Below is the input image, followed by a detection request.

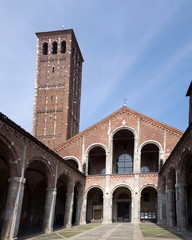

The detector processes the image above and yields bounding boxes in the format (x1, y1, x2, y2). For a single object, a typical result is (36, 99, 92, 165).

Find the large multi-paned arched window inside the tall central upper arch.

(117, 153, 133, 174)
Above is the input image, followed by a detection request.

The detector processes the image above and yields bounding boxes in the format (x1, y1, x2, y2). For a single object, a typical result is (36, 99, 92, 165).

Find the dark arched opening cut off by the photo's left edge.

(0, 142, 10, 234)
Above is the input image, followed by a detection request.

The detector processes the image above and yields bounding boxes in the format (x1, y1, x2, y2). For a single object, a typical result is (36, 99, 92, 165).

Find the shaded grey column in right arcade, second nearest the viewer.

(166, 189, 175, 227)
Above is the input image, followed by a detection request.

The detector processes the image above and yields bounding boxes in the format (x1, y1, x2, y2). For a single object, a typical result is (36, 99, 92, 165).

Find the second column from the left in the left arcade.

(43, 187, 57, 233)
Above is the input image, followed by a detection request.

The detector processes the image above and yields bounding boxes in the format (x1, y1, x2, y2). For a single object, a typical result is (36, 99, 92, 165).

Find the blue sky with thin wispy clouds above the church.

(0, 0, 192, 132)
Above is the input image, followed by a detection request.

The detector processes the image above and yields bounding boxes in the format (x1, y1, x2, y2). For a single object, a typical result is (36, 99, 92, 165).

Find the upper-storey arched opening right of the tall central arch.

(141, 144, 159, 173)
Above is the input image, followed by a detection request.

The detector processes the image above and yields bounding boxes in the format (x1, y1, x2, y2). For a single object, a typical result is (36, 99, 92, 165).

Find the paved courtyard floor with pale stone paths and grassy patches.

(19, 223, 192, 240)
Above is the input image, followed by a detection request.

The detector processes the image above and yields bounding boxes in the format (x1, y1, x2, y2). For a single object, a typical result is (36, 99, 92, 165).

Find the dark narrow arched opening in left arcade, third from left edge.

(54, 175, 68, 228)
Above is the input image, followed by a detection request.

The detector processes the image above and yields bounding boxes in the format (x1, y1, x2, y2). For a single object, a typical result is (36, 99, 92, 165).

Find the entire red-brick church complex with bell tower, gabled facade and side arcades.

(0, 30, 192, 239)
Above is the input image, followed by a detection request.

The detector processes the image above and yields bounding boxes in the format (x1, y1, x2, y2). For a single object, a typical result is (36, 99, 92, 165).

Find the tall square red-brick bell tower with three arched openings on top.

(32, 29, 83, 149)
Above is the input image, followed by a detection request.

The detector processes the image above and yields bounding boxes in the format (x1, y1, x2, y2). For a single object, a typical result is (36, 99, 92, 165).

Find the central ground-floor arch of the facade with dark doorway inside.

(112, 187, 131, 222)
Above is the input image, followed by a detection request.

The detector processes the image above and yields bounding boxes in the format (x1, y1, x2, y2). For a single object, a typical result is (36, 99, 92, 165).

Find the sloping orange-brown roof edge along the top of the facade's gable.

(53, 105, 183, 152)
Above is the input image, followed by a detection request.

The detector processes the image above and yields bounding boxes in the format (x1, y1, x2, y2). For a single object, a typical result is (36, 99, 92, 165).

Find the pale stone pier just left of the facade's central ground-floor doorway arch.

(103, 193, 112, 223)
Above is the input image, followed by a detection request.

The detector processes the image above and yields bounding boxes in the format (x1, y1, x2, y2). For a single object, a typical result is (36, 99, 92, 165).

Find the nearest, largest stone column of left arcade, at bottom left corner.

(1, 177, 26, 240)
